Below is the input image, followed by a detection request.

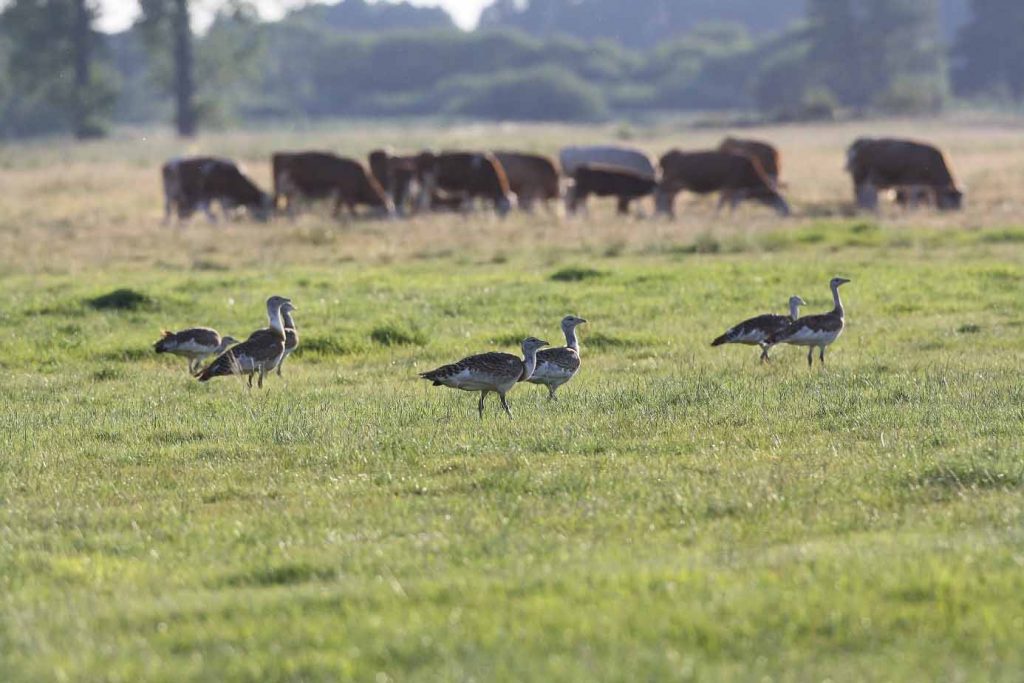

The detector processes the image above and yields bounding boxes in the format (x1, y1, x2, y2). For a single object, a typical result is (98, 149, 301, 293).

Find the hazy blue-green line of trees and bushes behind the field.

(0, 0, 1024, 137)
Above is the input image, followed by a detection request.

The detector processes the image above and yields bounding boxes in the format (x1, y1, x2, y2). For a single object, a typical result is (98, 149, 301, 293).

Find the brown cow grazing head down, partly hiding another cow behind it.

(655, 150, 790, 216)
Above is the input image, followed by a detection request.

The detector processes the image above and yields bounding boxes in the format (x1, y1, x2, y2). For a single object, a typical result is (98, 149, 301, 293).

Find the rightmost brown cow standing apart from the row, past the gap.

(846, 137, 964, 211)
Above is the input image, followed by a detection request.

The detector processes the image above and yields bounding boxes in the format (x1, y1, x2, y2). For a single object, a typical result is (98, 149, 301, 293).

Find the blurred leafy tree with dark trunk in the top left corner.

(0, 0, 116, 138)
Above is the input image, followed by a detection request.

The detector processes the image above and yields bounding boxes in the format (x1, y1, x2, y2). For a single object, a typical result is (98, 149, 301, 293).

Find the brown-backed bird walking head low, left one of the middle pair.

(420, 337, 548, 420)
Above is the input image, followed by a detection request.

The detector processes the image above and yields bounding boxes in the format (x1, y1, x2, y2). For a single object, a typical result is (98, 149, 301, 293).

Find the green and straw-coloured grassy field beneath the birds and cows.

(0, 122, 1024, 681)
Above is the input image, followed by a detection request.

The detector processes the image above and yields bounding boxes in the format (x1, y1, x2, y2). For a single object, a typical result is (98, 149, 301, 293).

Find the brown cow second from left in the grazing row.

(270, 152, 394, 216)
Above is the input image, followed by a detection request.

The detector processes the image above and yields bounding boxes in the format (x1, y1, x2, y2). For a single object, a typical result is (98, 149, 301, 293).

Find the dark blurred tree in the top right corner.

(952, 0, 1024, 100)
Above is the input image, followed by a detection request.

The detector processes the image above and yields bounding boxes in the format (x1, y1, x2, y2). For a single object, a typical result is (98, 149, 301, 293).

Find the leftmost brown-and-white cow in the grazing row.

(160, 157, 271, 223)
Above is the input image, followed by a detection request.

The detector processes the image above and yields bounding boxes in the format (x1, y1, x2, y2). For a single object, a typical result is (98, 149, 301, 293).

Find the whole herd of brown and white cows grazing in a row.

(162, 137, 963, 221)
